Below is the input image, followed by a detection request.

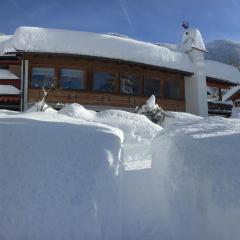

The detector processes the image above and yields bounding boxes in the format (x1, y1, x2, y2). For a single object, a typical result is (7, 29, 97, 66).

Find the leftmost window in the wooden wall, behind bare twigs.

(31, 67, 55, 88)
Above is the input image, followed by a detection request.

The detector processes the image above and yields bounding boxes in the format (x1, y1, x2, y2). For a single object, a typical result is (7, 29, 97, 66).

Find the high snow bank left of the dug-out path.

(0, 111, 122, 240)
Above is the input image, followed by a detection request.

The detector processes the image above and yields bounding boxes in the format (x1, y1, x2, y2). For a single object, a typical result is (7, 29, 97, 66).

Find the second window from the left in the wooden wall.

(60, 68, 85, 90)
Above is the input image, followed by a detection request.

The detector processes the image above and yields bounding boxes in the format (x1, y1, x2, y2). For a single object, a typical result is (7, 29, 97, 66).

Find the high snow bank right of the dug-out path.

(151, 113, 240, 240)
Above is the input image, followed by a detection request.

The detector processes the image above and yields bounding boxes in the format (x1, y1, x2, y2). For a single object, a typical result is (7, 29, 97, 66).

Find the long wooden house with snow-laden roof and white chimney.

(0, 27, 240, 116)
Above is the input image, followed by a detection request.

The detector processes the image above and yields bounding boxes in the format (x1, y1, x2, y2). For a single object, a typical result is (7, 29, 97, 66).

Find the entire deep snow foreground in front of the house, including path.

(0, 104, 240, 240)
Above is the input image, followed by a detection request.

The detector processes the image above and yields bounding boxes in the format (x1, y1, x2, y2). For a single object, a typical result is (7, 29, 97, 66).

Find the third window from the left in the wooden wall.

(93, 72, 115, 92)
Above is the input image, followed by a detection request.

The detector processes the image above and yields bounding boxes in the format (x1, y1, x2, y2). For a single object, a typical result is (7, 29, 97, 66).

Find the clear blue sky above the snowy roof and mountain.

(0, 0, 240, 43)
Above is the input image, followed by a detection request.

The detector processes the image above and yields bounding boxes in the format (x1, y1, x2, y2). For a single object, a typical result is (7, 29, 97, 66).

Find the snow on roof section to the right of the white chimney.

(205, 60, 240, 84)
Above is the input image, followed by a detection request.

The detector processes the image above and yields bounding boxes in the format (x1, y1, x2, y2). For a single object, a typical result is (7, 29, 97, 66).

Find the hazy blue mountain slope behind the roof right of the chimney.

(206, 40, 240, 69)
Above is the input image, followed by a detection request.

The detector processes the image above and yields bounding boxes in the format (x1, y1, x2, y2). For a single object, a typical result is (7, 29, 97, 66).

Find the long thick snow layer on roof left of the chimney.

(0, 27, 193, 72)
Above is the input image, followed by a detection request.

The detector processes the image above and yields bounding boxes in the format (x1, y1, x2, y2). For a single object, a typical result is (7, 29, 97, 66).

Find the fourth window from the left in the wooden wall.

(120, 74, 139, 95)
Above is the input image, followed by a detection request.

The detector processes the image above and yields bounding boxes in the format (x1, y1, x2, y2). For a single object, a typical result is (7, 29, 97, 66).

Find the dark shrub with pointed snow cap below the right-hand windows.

(135, 95, 167, 125)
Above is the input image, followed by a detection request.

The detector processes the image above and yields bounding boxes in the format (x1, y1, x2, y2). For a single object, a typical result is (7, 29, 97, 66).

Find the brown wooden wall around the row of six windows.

(25, 54, 185, 111)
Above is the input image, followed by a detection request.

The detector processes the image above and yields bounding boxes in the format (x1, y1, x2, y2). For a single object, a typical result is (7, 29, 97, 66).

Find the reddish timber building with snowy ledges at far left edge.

(0, 69, 21, 110)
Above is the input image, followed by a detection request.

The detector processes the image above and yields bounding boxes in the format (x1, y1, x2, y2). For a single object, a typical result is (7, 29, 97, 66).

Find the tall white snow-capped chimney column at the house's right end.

(183, 29, 208, 117)
